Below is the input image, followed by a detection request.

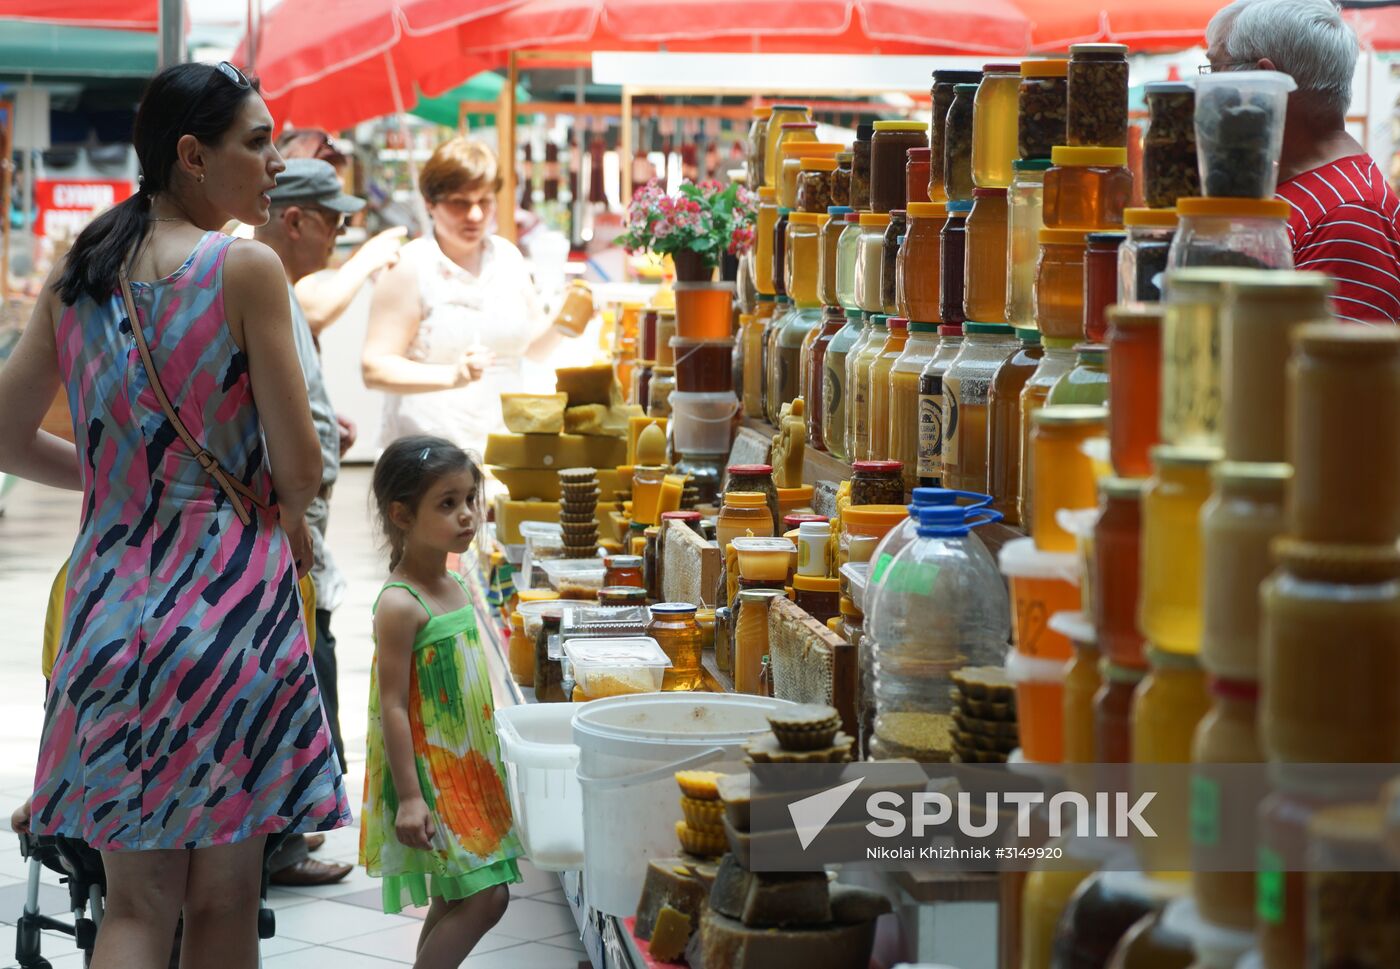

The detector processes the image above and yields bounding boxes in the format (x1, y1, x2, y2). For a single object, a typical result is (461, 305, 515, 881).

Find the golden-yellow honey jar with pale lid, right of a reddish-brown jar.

(1138, 444, 1219, 655)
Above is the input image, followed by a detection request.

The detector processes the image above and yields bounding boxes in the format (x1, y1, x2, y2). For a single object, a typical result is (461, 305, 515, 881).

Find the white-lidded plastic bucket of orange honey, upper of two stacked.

(1000, 538, 1079, 663)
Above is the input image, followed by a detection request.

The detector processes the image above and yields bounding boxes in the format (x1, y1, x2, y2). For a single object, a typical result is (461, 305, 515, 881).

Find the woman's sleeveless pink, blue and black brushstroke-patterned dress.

(32, 232, 350, 850)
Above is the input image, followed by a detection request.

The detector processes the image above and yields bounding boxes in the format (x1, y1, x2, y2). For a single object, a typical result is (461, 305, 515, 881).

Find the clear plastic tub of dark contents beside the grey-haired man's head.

(1196, 70, 1298, 199)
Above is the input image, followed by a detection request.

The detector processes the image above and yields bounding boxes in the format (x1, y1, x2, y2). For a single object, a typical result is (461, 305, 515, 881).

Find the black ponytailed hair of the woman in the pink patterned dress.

(57, 64, 258, 305)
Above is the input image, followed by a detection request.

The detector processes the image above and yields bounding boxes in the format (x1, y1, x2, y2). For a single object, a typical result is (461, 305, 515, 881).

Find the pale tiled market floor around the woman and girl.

(0, 466, 585, 969)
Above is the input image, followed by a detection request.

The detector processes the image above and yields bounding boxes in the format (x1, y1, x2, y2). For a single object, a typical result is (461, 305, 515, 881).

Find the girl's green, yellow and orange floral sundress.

(360, 573, 524, 913)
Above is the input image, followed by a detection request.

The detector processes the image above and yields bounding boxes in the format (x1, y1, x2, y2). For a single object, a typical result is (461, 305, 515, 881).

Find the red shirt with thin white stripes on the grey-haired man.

(1278, 154, 1400, 323)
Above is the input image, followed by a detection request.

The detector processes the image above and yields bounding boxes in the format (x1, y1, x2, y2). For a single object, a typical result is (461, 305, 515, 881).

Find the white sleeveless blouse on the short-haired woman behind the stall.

(379, 232, 549, 456)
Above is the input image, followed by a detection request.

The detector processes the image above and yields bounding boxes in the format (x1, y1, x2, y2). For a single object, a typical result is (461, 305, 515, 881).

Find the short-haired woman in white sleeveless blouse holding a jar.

(361, 137, 576, 455)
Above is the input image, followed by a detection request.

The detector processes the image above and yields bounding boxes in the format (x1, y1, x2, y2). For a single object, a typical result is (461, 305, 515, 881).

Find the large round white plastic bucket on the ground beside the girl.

(574, 693, 794, 917)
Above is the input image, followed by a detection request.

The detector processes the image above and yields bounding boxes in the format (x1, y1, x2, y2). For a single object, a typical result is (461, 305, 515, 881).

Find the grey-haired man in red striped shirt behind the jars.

(1205, 0, 1400, 323)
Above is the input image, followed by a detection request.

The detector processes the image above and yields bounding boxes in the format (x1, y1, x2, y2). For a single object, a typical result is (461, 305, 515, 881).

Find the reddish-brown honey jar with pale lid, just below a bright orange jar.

(1093, 477, 1147, 669)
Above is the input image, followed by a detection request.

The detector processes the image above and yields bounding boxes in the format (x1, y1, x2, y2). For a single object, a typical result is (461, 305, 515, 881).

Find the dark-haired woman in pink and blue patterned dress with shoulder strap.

(0, 63, 350, 969)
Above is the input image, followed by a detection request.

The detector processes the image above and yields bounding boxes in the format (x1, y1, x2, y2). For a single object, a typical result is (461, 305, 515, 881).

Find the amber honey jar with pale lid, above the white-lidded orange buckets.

(1030, 405, 1109, 552)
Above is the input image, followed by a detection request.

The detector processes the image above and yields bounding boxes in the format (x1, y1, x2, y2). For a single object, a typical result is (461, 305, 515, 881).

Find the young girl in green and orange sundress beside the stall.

(360, 437, 522, 969)
